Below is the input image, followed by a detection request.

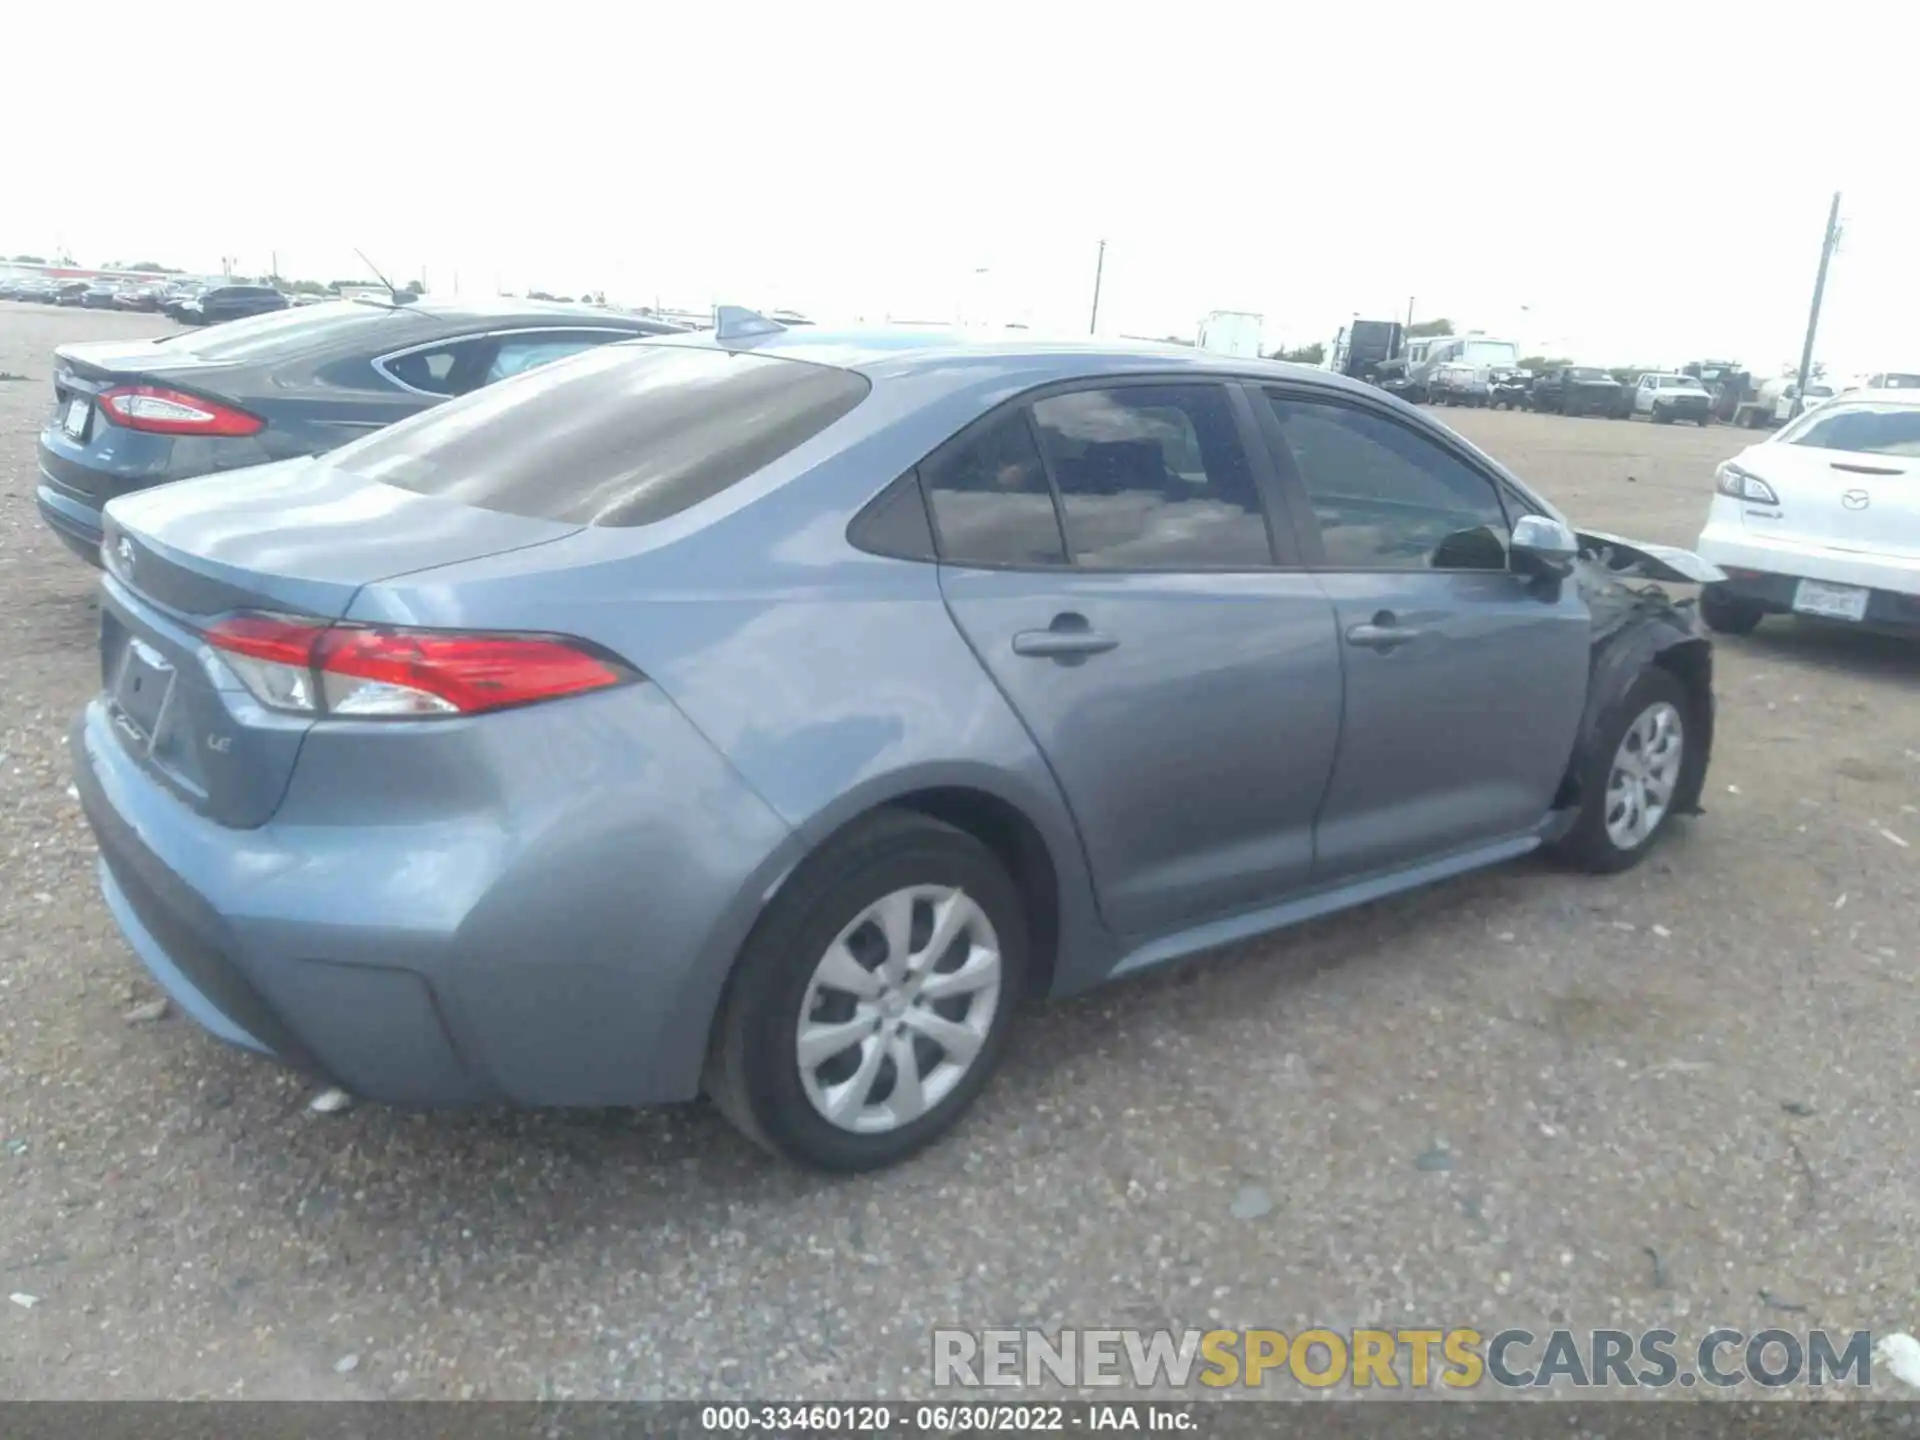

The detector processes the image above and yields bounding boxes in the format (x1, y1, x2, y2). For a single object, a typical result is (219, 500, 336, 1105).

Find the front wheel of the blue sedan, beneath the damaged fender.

(1549, 664, 1692, 876)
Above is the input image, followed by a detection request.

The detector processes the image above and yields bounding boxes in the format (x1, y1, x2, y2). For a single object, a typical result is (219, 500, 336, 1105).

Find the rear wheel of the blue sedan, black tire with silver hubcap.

(707, 810, 1027, 1173)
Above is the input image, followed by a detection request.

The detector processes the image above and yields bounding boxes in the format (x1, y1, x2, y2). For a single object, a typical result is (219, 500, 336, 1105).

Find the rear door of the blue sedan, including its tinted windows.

(922, 380, 1340, 935)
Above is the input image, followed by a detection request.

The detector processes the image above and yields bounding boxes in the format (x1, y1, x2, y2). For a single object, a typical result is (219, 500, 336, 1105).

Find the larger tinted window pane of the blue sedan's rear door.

(1033, 386, 1273, 570)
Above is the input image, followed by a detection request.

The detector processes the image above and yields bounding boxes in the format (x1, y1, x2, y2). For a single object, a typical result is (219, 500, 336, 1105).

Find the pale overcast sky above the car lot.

(0, 0, 1920, 372)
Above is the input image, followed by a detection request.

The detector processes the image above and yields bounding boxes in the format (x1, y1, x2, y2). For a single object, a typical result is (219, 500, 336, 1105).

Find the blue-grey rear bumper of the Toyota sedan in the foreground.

(71, 685, 797, 1106)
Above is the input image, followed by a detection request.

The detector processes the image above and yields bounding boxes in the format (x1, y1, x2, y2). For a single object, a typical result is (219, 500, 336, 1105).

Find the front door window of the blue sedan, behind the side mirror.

(1271, 396, 1509, 570)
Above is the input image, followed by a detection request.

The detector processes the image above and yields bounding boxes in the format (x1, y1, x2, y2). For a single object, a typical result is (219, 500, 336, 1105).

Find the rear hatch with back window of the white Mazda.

(1751, 399, 1920, 559)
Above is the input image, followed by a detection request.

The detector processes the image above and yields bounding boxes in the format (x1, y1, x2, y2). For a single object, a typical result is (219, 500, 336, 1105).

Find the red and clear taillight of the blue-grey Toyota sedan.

(207, 614, 639, 720)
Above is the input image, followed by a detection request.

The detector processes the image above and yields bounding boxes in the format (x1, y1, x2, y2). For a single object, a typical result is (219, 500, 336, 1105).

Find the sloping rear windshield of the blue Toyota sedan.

(334, 342, 868, 526)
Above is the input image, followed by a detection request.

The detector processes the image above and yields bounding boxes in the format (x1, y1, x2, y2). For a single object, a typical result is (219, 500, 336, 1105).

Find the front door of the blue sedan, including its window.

(1263, 388, 1592, 881)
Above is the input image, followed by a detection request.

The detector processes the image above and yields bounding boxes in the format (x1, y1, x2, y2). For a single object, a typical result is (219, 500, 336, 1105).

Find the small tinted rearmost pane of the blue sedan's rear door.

(922, 409, 1068, 564)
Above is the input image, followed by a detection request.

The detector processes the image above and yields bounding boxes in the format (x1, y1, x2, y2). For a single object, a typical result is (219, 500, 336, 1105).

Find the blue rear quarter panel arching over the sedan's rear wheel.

(349, 401, 1114, 1025)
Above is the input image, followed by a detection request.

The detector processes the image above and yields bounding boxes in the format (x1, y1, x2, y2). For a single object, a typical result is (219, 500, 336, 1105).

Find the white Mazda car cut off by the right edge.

(1695, 390, 1920, 636)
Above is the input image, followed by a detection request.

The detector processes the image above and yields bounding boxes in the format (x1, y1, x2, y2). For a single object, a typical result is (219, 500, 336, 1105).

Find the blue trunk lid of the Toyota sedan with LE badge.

(100, 459, 580, 829)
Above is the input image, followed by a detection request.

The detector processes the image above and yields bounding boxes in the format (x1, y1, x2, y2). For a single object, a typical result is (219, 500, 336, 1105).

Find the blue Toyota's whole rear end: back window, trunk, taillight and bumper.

(73, 346, 866, 1104)
